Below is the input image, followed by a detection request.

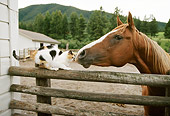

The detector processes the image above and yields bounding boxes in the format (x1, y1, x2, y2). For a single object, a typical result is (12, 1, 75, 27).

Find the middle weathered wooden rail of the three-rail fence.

(10, 84, 170, 106)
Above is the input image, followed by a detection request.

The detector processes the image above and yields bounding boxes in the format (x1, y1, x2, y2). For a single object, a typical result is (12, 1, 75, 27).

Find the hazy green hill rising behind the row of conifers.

(19, 4, 93, 22)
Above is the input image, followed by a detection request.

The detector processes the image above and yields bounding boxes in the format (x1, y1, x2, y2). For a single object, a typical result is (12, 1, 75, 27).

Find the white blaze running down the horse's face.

(76, 30, 118, 59)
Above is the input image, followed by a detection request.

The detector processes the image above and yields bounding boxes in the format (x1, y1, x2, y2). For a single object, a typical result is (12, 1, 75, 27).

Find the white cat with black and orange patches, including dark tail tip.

(13, 46, 75, 71)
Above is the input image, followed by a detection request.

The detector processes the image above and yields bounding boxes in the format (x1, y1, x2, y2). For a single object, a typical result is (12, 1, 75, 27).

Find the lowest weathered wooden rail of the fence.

(10, 100, 135, 116)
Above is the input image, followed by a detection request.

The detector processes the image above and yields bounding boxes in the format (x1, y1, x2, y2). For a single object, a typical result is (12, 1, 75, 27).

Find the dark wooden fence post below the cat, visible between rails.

(36, 78, 52, 116)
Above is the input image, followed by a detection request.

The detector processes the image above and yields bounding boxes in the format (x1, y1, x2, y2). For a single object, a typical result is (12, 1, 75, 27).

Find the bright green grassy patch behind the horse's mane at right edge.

(150, 32, 170, 52)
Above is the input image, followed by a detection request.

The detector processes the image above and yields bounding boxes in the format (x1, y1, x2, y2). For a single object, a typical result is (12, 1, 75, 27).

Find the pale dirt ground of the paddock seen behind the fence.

(20, 61, 144, 116)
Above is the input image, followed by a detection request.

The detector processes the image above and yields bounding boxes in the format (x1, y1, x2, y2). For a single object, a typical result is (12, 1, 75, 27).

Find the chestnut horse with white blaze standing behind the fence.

(76, 12, 170, 116)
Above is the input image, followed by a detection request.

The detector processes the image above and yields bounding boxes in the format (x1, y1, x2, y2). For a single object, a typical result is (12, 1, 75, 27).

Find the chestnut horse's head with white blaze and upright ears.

(76, 12, 136, 68)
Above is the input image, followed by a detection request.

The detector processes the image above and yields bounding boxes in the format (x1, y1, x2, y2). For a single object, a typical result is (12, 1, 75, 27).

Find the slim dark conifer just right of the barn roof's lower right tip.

(62, 14, 69, 39)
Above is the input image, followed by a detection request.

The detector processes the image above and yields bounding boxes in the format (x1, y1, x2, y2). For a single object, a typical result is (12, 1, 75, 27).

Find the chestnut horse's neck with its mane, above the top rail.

(133, 33, 170, 74)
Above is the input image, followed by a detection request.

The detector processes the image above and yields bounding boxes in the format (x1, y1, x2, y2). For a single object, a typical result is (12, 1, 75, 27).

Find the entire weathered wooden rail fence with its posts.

(9, 66, 170, 116)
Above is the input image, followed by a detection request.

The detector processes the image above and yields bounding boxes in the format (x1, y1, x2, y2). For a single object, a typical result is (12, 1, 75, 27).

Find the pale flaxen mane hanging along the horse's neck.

(136, 30, 170, 74)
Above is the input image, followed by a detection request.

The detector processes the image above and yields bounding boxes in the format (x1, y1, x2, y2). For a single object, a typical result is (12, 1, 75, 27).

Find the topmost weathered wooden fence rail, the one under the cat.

(9, 66, 170, 87)
